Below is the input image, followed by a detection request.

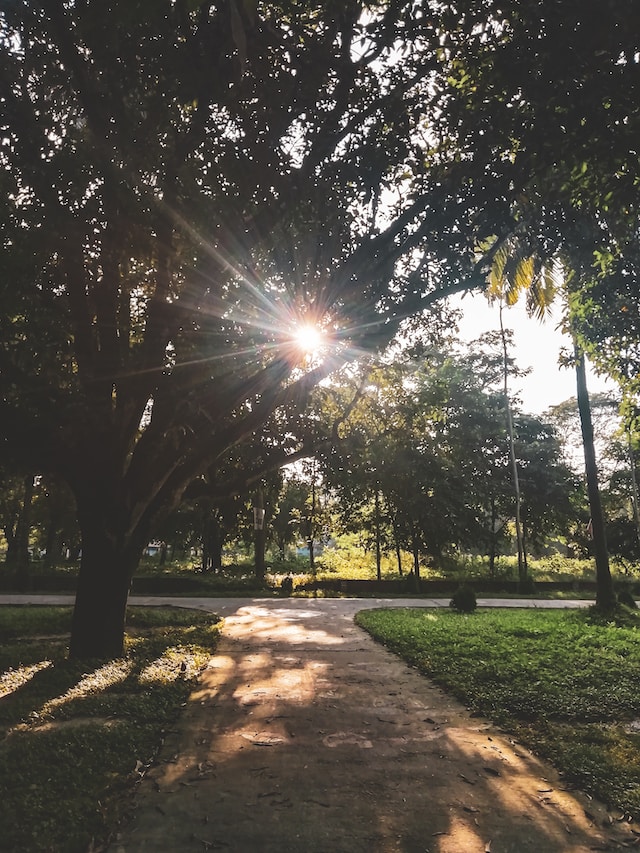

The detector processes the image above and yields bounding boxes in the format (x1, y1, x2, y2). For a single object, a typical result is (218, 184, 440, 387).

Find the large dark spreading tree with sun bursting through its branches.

(0, 0, 496, 656)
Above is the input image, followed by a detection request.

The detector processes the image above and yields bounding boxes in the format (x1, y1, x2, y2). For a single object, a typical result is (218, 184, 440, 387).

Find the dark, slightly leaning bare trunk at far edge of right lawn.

(574, 344, 616, 610)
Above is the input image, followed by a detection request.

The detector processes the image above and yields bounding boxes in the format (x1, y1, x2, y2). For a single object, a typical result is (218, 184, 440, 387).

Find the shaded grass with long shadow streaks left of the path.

(0, 607, 218, 853)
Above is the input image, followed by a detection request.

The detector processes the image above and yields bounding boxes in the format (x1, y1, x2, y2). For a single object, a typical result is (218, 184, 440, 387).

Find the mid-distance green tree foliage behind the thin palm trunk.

(318, 343, 586, 575)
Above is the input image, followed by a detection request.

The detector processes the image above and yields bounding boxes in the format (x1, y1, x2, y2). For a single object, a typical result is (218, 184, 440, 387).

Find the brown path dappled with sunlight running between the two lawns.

(109, 601, 637, 853)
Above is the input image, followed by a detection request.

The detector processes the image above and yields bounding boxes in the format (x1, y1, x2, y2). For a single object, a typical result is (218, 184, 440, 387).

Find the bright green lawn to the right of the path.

(356, 609, 640, 819)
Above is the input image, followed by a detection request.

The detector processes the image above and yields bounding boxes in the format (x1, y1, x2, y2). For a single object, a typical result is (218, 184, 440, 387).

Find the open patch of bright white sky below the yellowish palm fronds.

(455, 293, 612, 414)
